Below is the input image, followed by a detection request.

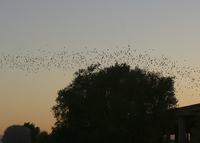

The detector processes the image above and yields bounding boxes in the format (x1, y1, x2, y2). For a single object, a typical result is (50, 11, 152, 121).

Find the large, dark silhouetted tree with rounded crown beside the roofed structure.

(52, 63, 177, 143)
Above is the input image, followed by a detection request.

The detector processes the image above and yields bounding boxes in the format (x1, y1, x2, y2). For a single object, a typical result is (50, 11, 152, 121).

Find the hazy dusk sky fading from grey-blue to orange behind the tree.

(0, 0, 200, 135)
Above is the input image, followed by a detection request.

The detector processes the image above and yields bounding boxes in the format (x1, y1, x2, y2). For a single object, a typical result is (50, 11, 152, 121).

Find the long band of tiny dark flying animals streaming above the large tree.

(0, 45, 200, 95)
